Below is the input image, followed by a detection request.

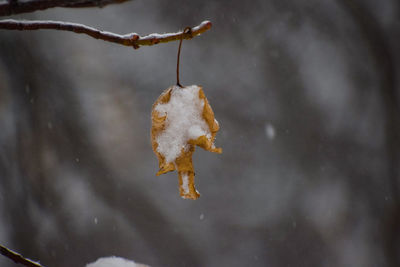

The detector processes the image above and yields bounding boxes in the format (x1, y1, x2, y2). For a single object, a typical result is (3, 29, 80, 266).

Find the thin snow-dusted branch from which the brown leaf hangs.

(0, 19, 212, 49)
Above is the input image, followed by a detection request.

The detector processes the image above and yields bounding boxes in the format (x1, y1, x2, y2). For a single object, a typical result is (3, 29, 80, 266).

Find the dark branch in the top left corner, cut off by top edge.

(0, 0, 128, 16)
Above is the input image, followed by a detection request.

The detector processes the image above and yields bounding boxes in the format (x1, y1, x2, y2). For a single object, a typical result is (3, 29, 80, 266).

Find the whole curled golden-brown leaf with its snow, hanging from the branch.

(151, 85, 222, 199)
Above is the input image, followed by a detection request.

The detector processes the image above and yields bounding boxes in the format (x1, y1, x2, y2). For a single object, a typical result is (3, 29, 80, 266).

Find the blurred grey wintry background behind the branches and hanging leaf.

(0, 0, 400, 267)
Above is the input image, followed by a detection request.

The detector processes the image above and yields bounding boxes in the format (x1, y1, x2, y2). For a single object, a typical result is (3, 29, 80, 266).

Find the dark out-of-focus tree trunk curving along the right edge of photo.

(338, 0, 400, 267)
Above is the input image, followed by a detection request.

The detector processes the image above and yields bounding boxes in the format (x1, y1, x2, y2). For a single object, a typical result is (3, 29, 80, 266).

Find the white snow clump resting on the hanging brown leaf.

(155, 85, 211, 163)
